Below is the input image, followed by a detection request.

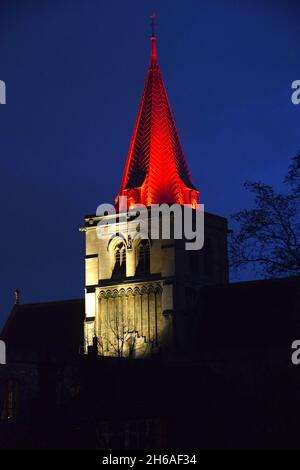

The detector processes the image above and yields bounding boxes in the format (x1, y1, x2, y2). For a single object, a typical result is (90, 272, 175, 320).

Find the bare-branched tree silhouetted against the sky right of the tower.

(230, 152, 300, 277)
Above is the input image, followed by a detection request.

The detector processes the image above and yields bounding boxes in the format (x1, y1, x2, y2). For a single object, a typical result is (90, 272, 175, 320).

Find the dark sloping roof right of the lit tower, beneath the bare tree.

(198, 276, 300, 351)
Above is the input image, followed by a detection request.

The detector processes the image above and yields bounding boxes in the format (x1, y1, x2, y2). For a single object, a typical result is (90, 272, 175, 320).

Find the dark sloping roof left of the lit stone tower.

(0, 299, 84, 361)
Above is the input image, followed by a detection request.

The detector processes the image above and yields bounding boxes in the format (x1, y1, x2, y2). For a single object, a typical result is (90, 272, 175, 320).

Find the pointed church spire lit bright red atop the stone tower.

(116, 17, 199, 207)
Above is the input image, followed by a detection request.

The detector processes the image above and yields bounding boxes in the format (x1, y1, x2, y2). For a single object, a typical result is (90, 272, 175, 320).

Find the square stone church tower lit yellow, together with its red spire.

(82, 28, 228, 358)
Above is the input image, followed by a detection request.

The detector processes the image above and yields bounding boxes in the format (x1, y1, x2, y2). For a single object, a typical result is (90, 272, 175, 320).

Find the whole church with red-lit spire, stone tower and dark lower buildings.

(0, 26, 300, 450)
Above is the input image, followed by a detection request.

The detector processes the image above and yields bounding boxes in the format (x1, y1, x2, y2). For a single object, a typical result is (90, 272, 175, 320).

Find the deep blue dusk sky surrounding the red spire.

(0, 0, 300, 323)
